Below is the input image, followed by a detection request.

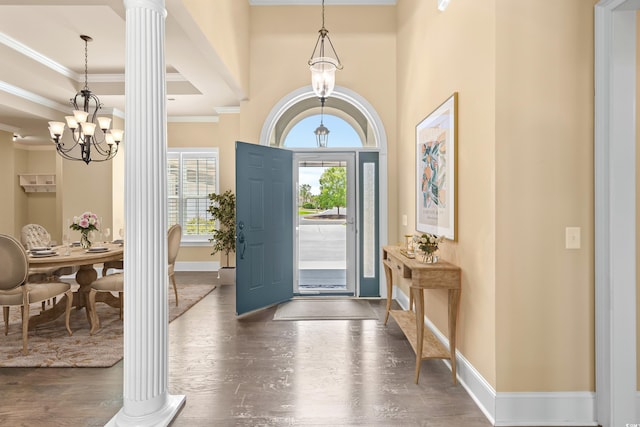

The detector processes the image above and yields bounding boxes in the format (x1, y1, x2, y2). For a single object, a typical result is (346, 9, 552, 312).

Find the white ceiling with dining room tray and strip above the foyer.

(0, 0, 395, 145)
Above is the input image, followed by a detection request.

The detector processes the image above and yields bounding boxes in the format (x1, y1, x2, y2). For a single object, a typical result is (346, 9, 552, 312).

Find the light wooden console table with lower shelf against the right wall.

(382, 246, 461, 384)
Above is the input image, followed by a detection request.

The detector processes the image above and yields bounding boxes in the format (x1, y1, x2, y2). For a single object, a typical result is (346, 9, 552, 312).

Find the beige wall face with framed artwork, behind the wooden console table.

(398, 0, 496, 386)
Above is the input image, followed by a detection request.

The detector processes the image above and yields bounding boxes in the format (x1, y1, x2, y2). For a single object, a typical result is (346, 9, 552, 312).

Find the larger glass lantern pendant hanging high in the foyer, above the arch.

(309, 0, 342, 99)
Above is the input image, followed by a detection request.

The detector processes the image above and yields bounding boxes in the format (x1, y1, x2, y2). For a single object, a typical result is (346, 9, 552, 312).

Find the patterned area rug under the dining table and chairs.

(0, 283, 216, 368)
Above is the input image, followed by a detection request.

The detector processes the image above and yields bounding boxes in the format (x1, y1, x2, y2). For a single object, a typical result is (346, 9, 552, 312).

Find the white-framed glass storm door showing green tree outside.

(293, 153, 357, 295)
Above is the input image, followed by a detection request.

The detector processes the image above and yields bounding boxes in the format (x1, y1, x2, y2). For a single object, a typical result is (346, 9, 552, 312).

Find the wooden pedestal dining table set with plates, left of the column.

(28, 242, 124, 330)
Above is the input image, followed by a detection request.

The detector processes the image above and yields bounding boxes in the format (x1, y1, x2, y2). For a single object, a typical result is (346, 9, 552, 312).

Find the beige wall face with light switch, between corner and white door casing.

(495, 0, 596, 391)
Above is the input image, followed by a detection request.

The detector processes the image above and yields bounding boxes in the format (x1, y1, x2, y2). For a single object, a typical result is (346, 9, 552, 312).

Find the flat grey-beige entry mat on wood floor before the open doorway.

(273, 299, 378, 320)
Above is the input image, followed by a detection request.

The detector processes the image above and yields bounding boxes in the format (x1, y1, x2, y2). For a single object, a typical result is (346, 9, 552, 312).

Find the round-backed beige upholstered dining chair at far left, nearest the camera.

(0, 234, 73, 355)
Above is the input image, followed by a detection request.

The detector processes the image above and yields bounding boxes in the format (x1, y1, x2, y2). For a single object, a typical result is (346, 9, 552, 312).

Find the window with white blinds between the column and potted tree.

(167, 149, 218, 243)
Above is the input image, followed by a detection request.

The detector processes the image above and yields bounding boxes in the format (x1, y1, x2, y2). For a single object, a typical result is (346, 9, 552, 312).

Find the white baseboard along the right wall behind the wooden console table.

(395, 287, 596, 427)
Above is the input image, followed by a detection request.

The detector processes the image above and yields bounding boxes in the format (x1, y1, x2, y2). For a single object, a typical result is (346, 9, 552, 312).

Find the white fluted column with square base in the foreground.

(107, 0, 185, 426)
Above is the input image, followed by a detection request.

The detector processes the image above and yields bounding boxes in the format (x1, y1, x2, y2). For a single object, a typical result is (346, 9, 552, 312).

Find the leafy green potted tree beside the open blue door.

(208, 190, 236, 285)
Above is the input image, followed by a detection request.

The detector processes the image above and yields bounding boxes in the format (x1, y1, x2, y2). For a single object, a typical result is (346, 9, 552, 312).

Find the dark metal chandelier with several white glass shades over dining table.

(49, 35, 124, 164)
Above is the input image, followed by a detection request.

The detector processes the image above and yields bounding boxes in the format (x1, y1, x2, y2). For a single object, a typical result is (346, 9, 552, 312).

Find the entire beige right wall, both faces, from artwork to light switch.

(397, 0, 595, 392)
